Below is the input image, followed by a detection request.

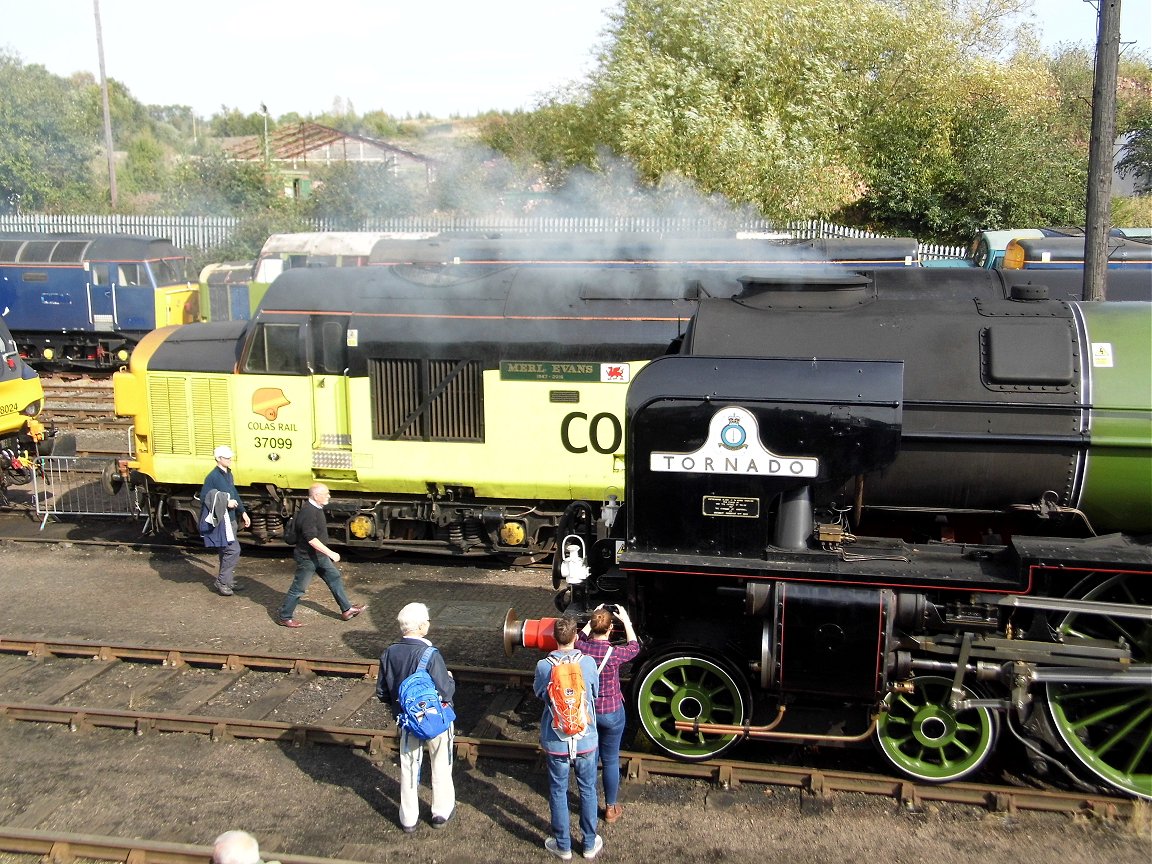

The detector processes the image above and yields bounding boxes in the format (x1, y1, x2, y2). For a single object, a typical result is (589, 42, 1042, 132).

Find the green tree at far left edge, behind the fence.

(0, 50, 100, 211)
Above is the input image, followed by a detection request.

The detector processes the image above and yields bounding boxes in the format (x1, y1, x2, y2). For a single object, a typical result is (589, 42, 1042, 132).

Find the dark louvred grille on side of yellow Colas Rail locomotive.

(369, 359, 484, 442)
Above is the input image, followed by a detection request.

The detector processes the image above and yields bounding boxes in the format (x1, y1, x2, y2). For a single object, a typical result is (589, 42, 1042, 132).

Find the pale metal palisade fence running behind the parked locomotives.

(0, 213, 964, 258)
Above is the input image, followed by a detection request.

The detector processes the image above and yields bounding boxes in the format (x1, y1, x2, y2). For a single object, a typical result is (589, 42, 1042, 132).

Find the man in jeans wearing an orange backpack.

(532, 616, 604, 861)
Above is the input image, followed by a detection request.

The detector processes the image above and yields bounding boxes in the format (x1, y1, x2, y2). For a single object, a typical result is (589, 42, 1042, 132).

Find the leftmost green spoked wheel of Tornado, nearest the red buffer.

(636, 655, 750, 760)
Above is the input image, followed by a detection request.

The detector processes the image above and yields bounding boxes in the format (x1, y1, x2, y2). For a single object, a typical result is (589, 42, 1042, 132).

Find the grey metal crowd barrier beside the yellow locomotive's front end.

(32, 456, 144, 531)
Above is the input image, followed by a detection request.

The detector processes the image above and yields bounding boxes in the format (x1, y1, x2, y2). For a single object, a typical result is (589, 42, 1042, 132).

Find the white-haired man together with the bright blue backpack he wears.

(376, 602, 456, 834)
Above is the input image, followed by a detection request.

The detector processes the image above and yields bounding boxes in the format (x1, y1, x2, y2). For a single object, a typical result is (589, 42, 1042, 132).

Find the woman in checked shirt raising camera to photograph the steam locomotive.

(576, 604, 641, 824)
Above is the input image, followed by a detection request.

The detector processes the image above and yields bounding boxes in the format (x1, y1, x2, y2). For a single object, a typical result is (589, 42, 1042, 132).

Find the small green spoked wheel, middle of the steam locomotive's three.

(876, 676, 1000, 783)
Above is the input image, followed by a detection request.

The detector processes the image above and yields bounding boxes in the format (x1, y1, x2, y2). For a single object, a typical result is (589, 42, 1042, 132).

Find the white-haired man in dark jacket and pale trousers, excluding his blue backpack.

(376, 602, 456, 834)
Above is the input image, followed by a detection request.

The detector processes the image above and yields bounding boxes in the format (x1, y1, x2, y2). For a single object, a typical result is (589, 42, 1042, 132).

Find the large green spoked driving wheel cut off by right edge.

(1047, 574, 1152, 798)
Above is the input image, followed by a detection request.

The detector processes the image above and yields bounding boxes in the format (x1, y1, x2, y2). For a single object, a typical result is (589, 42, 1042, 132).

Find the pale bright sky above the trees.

(0, 0, 1152, 119)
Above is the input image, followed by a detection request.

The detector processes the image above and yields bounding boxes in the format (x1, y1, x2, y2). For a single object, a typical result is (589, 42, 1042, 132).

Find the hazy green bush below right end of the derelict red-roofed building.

(309, 162, 416, 230)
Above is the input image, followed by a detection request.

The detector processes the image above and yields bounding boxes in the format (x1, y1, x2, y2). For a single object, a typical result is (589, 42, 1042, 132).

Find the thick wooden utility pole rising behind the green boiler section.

(1084, 0, 1121, 300)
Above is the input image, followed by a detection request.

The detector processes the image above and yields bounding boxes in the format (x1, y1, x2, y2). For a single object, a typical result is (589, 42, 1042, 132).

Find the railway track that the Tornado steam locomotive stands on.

(0, 637, 1137, 819)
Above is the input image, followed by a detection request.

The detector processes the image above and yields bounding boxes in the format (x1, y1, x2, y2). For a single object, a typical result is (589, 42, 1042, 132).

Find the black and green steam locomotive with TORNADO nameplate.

(520, 271, 1152, 797)
